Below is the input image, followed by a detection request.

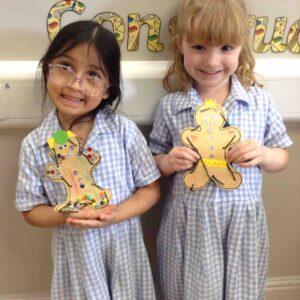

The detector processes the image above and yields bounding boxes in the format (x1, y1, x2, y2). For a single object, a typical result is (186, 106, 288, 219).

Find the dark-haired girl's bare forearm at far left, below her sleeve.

(23, 204, 67, 227)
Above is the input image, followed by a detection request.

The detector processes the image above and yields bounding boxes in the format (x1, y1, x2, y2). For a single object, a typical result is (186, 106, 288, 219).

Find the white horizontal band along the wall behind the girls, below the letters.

(0, 58, 300, 128)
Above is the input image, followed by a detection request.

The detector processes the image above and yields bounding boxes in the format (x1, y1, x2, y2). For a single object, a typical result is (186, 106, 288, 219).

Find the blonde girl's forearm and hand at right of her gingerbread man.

(227, 140, 289, 173)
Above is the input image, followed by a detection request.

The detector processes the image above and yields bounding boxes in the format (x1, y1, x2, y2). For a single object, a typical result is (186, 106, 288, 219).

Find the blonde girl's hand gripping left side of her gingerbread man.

(165, 146, 200, 173)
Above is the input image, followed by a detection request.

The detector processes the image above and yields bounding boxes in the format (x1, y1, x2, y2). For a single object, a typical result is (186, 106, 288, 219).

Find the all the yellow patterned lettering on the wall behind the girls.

(48, 0, 300, 54)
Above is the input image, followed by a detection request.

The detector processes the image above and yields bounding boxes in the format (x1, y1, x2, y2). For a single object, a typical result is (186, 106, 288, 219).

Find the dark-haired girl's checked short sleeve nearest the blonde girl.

(127, 124, 160, 187)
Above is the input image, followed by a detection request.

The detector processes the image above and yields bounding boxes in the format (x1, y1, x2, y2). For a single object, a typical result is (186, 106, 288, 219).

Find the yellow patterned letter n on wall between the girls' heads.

(127, 14, 164, 52)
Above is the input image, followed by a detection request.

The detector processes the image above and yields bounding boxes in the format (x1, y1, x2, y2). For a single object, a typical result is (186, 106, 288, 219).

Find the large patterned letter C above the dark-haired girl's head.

(48, 0, 85, 41)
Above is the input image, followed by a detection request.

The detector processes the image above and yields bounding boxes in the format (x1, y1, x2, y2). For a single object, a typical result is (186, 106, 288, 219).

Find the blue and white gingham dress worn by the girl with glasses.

(15, 111, 160, 300)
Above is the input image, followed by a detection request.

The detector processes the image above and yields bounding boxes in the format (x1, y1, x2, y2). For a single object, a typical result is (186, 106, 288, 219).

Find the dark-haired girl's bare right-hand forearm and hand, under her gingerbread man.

(66, 180, 160, 228)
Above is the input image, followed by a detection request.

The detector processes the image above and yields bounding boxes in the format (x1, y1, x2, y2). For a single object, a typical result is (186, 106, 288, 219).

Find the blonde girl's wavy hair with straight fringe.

(163, 0, 258, 92)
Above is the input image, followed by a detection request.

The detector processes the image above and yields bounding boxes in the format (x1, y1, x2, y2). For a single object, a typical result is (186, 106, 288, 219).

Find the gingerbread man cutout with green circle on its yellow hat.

(46, 130, 111, 212)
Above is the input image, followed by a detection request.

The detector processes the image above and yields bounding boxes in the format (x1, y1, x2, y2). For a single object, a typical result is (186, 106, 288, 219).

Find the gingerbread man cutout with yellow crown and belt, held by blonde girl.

(181, 99, 242, 190)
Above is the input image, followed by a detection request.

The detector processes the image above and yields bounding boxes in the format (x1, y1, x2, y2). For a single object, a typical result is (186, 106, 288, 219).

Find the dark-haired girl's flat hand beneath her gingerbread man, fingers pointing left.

(66, 205, 118, 229)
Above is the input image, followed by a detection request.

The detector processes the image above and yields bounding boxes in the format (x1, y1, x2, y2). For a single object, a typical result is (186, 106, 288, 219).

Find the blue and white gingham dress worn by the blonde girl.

(150, 75, 292, 300)
